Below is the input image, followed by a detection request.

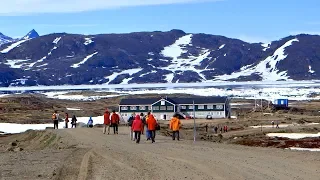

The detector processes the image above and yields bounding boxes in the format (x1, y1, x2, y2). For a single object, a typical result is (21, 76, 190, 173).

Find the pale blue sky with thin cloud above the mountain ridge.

(0, 0, 320, 42)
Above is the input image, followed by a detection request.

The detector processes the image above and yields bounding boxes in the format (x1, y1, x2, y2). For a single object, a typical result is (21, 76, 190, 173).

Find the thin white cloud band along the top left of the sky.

(0, 0, 223, 15)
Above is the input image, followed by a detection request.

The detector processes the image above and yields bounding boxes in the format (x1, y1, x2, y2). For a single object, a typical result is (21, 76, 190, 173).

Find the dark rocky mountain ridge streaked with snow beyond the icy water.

(0, 30, 320, 86)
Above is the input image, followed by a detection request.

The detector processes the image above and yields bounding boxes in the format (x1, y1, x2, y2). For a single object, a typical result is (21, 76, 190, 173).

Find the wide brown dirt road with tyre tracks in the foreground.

(0, 127, 320, 180)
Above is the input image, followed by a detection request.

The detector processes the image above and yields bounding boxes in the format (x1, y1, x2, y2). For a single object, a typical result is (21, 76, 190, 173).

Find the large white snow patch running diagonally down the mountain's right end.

(216, 38, 299, 81)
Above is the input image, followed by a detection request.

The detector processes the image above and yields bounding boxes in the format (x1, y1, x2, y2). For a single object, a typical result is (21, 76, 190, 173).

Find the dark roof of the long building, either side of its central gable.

(120, 96, 227, 105)
